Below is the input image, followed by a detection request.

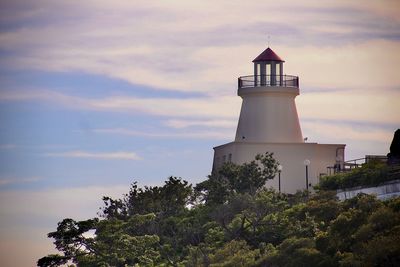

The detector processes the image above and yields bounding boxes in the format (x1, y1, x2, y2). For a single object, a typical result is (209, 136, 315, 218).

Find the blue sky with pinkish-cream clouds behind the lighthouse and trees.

(0, 0, 400, 266)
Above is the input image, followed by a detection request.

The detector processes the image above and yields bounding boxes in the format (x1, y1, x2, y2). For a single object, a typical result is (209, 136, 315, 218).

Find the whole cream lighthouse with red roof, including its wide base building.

(213, 47, 345, 193)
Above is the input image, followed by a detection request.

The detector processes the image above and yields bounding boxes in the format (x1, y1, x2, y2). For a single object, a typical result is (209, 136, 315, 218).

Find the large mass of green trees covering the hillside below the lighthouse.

(38, 153, 400, 267)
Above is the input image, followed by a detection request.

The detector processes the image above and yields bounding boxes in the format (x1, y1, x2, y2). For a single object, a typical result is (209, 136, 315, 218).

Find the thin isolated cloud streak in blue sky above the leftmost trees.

(45, 150, 141, 160)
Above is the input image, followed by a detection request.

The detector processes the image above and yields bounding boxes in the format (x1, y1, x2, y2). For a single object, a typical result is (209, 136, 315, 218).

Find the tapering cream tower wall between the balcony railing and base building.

(235, 86, 303, 143)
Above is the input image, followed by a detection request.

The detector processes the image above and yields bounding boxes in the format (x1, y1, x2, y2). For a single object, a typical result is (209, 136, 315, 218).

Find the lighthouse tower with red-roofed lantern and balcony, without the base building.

(235, 47, 303, 143)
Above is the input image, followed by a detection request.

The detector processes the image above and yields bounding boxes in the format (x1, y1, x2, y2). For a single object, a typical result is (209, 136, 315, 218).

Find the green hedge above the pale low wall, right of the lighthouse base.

(318, 161, 400, 190)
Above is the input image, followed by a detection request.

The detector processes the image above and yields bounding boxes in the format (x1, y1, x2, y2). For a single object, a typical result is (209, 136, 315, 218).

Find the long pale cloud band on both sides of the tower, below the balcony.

(0, 85, 400, 128)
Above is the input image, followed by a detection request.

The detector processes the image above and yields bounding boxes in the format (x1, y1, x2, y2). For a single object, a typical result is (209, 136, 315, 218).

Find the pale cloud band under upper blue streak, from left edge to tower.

(0, 90, 240, 118)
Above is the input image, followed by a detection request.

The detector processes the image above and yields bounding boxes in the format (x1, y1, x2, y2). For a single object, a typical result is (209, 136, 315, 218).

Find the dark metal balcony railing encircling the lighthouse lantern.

(238, 75, 299, 88)
